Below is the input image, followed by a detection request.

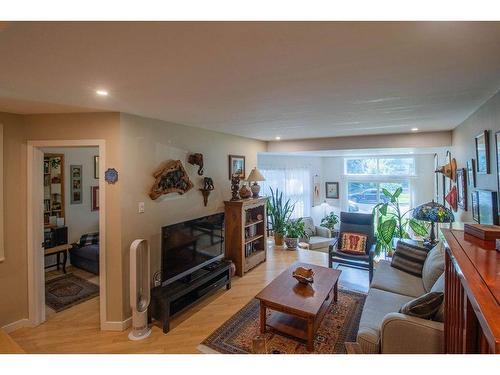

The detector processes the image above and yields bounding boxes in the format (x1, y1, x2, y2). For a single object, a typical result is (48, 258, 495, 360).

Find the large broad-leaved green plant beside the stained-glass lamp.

(373, 187, 427, 255)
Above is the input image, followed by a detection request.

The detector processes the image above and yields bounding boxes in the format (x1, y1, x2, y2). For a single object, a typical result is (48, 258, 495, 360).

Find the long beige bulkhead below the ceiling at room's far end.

(268, 131, 451, 152)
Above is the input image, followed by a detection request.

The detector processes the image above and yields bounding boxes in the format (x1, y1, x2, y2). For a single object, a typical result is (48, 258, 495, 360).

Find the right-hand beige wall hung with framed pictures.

(452, 91, 500, 222)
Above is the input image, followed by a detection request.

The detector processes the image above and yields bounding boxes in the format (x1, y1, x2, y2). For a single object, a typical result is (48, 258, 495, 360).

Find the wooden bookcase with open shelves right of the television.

(224, 197, 267, 277)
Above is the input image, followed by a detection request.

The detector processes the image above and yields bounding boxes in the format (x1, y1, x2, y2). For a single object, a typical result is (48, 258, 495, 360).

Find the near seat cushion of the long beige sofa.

(357, 290, 413, 354)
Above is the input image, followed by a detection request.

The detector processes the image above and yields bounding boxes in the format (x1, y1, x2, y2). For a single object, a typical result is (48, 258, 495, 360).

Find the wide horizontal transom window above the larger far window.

(345, 157, 415, 176)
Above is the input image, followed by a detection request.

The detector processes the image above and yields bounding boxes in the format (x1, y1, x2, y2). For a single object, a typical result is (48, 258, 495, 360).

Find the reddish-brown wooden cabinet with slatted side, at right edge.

(441, 229, 500, 354)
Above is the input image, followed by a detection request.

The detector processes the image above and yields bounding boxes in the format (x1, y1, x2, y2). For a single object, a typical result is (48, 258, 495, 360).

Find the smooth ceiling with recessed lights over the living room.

(0, 22, 500, 140)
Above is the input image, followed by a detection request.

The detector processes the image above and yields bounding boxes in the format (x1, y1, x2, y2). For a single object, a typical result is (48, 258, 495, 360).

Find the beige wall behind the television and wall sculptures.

(120, 114, 266, 316)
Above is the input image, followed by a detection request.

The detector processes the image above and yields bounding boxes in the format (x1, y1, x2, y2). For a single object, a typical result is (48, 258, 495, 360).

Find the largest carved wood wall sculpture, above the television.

(149, 160, 193, 200)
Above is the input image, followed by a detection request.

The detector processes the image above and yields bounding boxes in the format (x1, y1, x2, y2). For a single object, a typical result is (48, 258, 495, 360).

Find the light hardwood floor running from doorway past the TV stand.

(7, 242, 368, 353)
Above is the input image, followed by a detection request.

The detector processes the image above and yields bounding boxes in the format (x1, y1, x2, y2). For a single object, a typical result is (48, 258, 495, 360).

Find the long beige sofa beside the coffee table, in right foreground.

(357, 245, 444, 354)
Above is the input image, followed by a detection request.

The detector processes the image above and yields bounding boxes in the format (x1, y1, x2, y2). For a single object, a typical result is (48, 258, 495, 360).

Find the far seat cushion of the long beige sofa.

(370, 260, 426, 298)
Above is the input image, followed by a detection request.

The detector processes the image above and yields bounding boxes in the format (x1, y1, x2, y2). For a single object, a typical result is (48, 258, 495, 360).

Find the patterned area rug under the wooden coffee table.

(198, 289, 366, 354)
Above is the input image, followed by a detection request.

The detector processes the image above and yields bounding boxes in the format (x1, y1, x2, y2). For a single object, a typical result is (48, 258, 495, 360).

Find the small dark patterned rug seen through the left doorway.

(45, 274, 99, 312)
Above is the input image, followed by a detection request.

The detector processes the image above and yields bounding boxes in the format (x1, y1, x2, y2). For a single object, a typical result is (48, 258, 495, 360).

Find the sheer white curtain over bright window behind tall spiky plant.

(260, 168, 312, 219)
